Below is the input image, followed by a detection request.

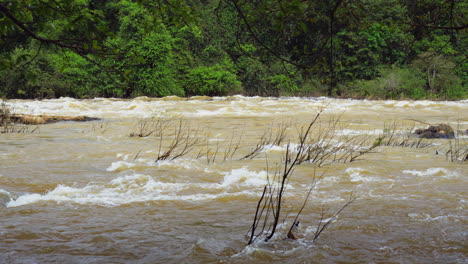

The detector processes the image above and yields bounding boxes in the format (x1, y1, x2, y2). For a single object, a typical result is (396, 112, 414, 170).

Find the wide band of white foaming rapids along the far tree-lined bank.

(8, 96, 467, 118)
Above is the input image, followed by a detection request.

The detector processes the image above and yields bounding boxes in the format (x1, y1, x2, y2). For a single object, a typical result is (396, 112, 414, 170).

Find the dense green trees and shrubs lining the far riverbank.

(0, 0, 468, 99)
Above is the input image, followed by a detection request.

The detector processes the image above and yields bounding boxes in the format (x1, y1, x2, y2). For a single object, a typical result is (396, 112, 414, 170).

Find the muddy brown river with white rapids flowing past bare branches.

(0, 96, 468, 263)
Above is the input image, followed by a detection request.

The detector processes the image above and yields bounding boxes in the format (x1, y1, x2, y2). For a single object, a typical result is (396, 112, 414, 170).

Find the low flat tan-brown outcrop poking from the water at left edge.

(0, 112, 99, 125)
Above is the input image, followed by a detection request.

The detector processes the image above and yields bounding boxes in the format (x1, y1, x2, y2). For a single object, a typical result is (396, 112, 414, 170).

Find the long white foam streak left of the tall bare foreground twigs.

(5, 171, 274, 207)
